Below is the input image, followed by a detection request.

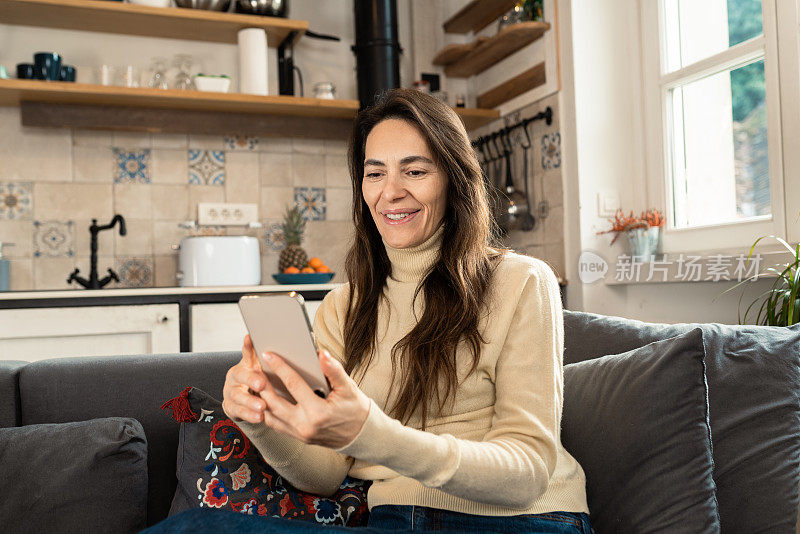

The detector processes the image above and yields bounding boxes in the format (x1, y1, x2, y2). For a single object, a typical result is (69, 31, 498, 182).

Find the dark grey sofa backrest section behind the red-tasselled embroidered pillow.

(16, 352, 241, 525)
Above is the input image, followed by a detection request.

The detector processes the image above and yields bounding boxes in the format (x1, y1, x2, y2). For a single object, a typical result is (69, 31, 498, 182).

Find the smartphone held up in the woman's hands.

(239, 291, 330, 402)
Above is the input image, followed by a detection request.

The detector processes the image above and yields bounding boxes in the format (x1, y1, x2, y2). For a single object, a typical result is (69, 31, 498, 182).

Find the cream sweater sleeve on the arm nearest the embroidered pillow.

(236, 291, 353, 496)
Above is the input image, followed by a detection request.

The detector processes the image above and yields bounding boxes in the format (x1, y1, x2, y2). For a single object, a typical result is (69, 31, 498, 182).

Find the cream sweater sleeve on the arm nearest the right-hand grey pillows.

(338, 262, 564, 509)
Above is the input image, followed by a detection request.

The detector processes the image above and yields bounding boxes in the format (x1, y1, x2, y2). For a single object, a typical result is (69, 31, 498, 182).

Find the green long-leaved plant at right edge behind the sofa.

(723, 235, 800, 326)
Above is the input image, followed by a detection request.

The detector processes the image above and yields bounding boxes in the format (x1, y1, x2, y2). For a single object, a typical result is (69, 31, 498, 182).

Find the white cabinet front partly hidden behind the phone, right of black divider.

(191, 300, 322, 352)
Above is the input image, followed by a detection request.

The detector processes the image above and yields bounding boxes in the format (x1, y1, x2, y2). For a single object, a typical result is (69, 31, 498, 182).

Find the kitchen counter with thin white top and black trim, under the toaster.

(0, 284, 341, 352)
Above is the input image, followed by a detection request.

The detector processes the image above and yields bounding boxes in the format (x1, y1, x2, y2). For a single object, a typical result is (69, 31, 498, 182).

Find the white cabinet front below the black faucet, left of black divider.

(0, 304, 180, 361)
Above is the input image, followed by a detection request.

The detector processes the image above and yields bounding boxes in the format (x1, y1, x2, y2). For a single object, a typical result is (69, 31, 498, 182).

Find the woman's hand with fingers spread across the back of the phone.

(260, 351, 369, 449)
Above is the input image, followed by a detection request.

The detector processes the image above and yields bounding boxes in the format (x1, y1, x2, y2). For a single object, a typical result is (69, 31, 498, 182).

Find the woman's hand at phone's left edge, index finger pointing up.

(222, 336, 268, 423)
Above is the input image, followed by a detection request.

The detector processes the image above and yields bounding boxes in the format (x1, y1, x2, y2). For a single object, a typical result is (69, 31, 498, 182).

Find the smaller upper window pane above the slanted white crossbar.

(664, 0, 763, 72)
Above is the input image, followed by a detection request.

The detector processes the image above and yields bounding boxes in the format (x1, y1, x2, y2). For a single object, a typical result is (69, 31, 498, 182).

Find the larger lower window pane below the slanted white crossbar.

(669, 59, 771, 228)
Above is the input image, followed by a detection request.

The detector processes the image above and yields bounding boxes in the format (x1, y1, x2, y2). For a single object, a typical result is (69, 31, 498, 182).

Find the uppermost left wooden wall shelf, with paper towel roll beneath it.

(0, 0, 308, 47)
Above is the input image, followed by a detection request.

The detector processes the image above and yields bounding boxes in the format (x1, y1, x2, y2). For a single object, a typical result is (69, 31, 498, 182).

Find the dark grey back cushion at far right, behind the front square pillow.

(564, 311, 800, 532)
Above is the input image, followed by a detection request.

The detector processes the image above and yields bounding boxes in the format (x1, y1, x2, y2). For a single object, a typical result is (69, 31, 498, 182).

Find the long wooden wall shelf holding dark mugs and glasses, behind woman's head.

(0, 80, 500, 139)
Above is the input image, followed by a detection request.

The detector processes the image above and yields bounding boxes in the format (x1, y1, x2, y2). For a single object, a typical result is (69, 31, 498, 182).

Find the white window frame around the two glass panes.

(639, 0, 800, 253)
